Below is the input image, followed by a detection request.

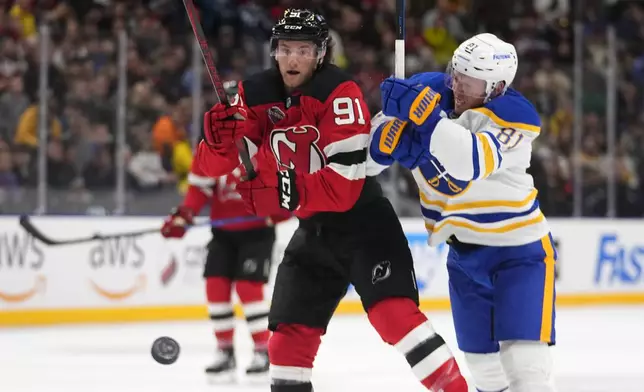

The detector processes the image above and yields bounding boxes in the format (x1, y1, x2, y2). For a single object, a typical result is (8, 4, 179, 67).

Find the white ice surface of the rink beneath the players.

(0, 307, 644, 392)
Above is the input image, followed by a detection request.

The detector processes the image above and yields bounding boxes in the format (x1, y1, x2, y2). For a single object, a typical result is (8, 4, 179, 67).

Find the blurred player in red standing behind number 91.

(161, 84, 290, 382)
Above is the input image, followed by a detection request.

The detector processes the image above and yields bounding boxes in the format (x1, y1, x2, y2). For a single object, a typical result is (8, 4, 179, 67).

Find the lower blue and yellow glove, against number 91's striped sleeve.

(369, 118, 431, 170)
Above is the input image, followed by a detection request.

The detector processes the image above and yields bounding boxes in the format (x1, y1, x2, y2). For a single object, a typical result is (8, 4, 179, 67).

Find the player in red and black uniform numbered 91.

(197, 9, 467, 392)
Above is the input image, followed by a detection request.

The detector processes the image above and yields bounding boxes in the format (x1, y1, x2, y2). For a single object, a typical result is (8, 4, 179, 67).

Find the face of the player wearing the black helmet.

(275, 41, 318, 88)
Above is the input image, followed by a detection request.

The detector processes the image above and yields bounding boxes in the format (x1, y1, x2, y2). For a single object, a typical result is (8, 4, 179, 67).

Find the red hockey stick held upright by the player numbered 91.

(183, 0, 257, 180)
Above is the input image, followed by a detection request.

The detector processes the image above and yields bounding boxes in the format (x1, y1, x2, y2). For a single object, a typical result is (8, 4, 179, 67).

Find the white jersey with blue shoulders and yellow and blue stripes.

(367, 77, 550, 246)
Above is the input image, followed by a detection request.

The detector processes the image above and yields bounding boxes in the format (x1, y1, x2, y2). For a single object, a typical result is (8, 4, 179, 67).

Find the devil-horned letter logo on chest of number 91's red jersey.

(271, 125, 324, 173)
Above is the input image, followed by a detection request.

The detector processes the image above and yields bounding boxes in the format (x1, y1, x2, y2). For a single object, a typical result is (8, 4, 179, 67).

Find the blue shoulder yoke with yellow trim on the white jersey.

(472, 89, 541, 132)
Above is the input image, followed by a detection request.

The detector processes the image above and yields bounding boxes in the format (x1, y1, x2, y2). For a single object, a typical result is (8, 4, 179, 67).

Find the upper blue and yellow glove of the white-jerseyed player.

(380, 77, 441, 131)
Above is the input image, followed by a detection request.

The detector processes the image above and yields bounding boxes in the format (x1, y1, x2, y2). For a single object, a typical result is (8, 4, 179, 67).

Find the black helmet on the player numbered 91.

(271, 8, 329, 58)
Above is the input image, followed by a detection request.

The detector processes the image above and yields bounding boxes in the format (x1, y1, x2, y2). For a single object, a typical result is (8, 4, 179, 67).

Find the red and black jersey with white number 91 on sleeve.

(197, 65, 381, 218)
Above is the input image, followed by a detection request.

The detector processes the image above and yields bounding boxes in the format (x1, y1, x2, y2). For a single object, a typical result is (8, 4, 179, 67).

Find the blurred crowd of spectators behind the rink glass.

(0, 0, 644, 217)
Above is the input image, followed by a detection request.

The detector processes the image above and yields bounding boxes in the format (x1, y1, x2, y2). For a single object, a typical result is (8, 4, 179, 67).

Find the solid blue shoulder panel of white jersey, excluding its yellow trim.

(483, 88, 541, 127)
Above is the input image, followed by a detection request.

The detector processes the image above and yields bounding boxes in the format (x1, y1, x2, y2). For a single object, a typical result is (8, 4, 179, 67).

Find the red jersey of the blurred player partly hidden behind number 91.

(183, 161, 291, 231)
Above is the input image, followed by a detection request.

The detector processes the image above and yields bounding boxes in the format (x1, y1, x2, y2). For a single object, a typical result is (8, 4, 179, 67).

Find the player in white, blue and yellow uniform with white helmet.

(368, 34, 557, 392)
